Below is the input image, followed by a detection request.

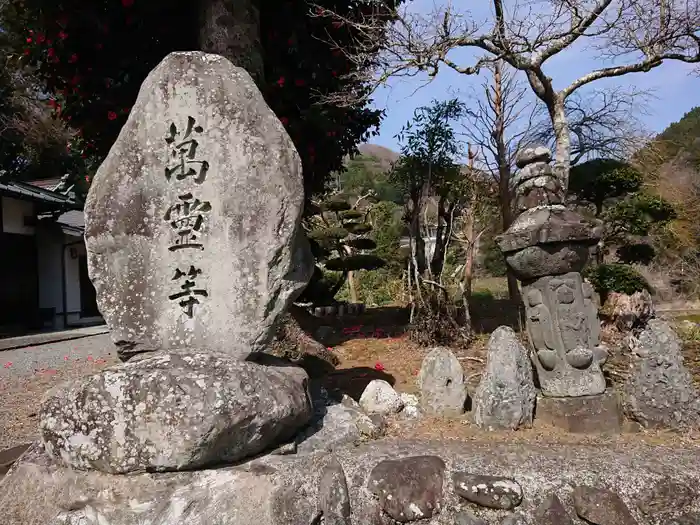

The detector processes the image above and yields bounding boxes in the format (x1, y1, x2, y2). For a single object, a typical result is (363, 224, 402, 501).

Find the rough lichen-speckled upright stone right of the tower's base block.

(623, 319, 700, 430)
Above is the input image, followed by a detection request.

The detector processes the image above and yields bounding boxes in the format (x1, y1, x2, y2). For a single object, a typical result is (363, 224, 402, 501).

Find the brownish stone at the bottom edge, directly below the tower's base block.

(573, 485, 638, 525)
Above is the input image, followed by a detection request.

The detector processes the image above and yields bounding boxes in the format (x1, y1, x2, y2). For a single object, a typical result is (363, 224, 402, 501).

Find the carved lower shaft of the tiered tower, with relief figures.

(523, 272, 608, 397)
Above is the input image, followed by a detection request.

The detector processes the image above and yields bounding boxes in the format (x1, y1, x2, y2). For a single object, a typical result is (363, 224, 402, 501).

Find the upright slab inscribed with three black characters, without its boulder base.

(85, 52, 313, 357)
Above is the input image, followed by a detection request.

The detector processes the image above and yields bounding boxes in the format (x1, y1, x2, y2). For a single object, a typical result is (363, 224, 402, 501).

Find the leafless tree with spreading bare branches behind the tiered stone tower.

(316, 0, 700, 191)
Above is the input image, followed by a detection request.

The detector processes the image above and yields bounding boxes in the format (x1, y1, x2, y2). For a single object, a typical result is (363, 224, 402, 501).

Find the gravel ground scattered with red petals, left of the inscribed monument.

(0, 334, 117, 450)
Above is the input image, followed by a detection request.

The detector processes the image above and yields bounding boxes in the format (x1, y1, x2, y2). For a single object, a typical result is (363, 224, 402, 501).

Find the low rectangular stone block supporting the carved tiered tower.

(535, 390, 623, 434)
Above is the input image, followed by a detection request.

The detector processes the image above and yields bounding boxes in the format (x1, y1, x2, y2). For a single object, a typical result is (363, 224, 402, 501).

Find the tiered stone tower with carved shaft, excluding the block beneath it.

(497, 147, 610, 430)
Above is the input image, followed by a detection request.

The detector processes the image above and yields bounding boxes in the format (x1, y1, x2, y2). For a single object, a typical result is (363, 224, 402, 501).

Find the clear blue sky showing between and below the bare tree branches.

(370, 0, 700, 150)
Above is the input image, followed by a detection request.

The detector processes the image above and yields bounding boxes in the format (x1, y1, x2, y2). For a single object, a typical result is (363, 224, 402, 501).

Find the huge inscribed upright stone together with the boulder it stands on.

(34, 52, 313, 474)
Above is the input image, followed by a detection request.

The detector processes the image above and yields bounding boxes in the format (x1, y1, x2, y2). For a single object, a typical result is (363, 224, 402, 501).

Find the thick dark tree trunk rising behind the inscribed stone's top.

(199, 0, 264, 86)
